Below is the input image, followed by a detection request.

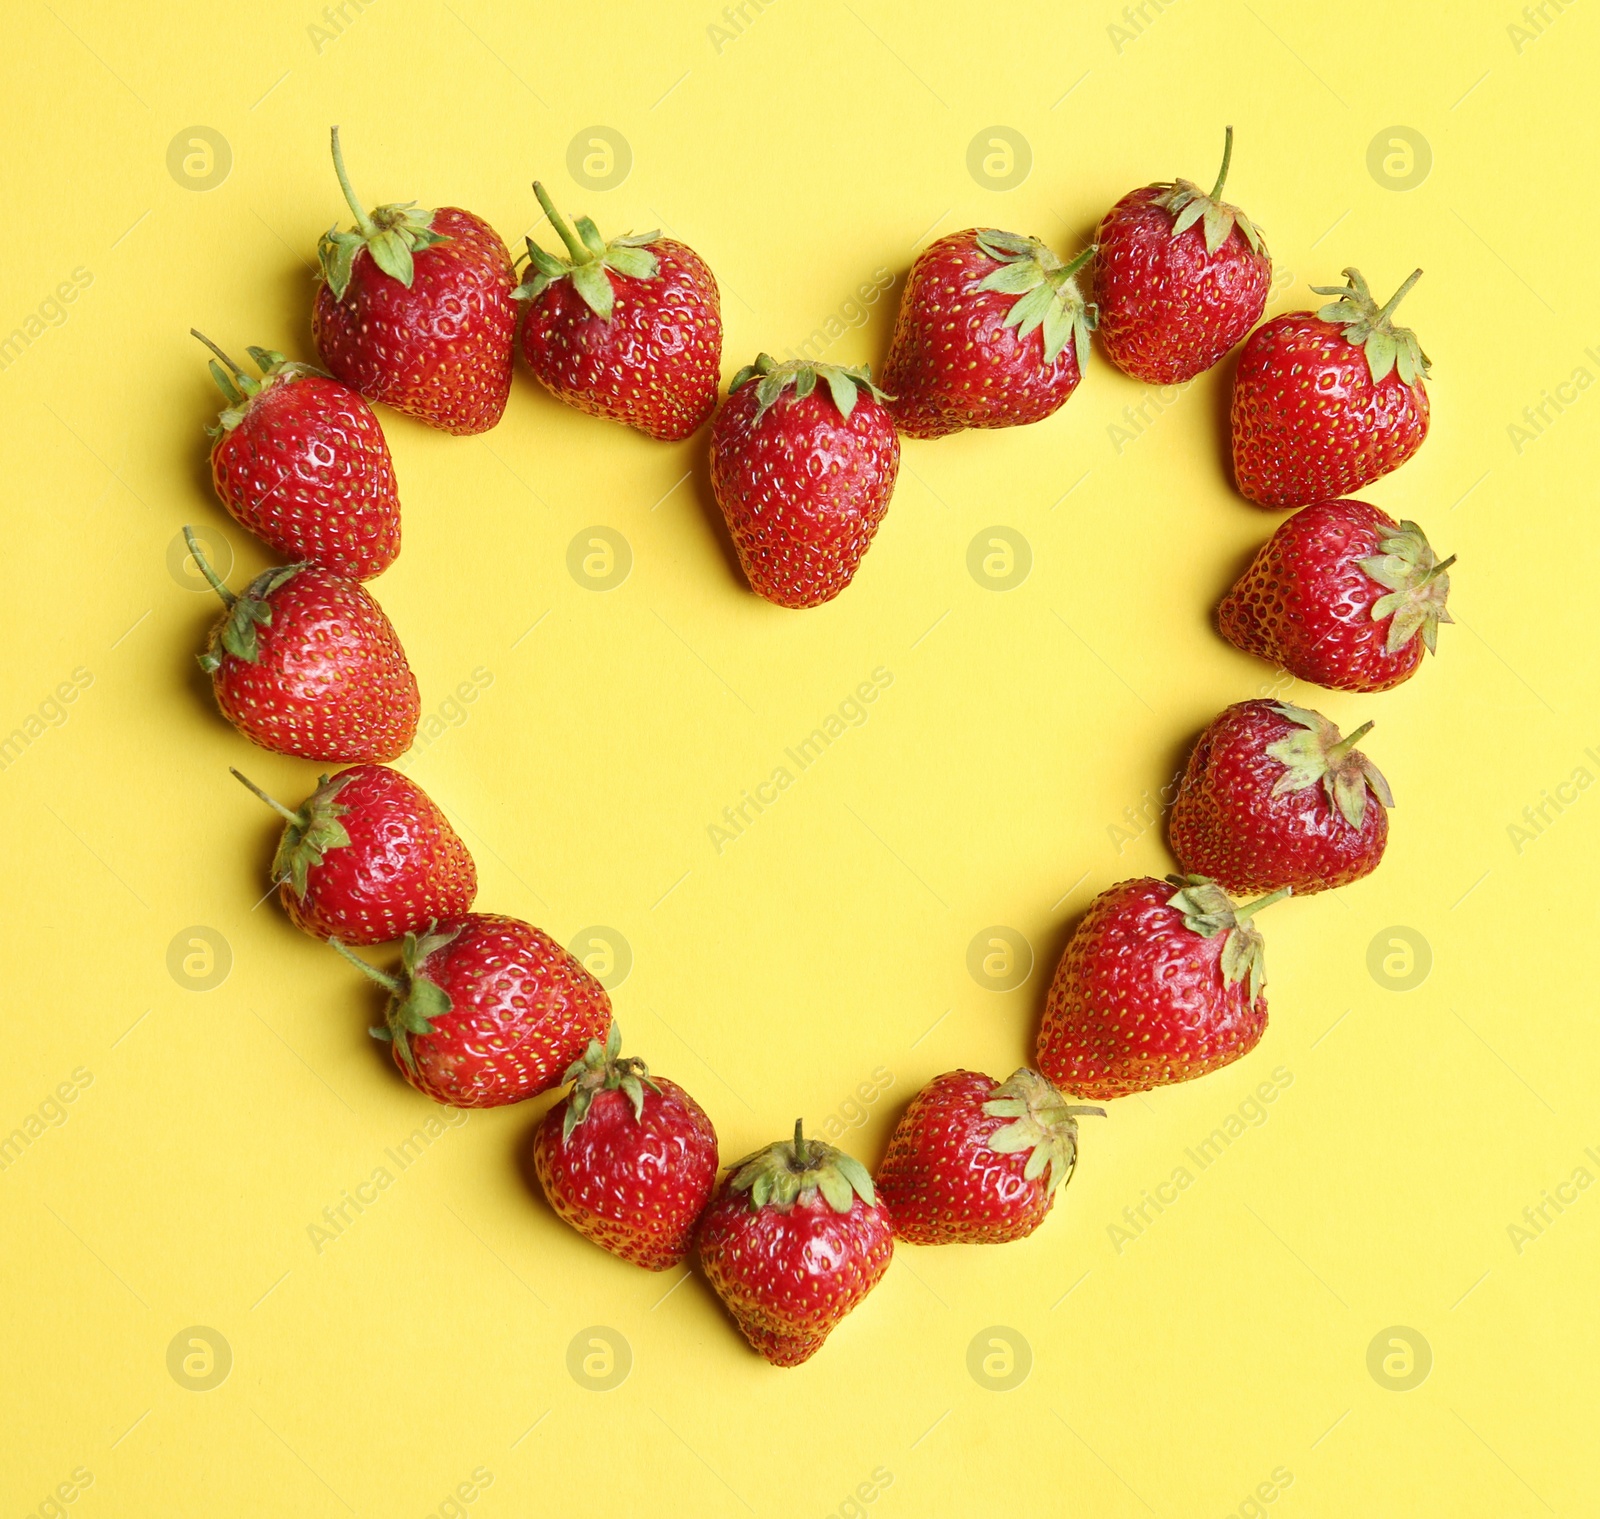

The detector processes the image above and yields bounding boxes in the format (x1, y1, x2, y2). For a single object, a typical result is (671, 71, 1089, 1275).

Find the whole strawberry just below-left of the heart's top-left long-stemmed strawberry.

(194, 333, 400, 579)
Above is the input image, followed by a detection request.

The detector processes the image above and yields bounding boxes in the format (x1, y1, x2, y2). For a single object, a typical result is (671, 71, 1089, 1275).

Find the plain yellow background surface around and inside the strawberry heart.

(0, 0, 1600, 1519)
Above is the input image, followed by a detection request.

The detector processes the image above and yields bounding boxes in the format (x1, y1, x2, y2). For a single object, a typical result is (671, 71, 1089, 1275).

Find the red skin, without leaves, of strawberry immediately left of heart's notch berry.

(520, 237, 722, 442)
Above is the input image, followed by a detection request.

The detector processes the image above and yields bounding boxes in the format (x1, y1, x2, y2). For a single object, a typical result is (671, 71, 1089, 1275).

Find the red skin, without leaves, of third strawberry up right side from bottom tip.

(1168, 701, 1389, 896)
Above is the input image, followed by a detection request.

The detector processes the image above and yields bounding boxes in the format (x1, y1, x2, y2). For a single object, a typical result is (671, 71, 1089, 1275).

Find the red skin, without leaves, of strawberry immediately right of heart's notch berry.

(882, 230, 1080, 439)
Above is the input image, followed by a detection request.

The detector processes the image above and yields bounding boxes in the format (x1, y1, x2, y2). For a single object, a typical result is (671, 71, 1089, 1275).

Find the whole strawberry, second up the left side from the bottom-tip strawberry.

(331, 912, 611, 1108)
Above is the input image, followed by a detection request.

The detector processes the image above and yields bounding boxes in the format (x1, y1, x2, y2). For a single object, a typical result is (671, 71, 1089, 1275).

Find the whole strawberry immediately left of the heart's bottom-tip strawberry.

(533, 1023, 717, 1271)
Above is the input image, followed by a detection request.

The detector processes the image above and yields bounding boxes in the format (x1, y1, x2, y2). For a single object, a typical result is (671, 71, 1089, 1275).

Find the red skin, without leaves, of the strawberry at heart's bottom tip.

(698, 1176, 894, 1365)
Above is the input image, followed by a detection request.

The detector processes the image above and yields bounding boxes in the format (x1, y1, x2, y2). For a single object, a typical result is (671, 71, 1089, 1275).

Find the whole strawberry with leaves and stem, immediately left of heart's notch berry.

(517, 182, 722, 442)
